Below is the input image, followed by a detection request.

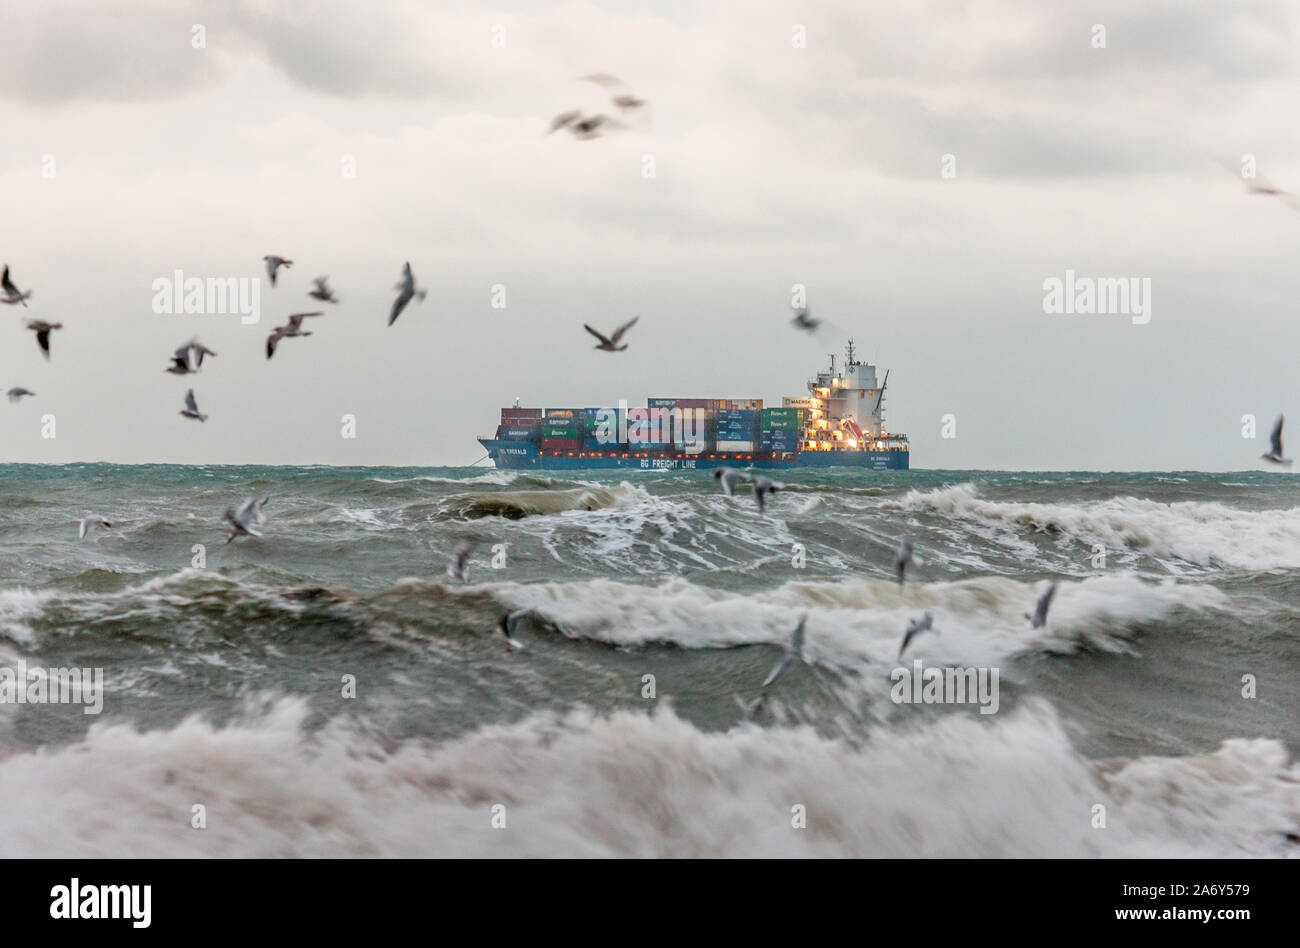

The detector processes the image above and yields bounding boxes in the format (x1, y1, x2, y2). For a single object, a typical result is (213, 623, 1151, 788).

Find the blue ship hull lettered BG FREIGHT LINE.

(478, 438, 909, 471)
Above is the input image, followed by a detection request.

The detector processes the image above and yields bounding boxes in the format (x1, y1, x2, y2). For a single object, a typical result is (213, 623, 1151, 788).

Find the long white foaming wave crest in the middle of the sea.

(490, 573, 1227, 668)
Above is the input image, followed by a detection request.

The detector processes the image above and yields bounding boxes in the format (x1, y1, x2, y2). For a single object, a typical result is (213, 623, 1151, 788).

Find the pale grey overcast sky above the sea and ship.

(0, 0, 1300, 469)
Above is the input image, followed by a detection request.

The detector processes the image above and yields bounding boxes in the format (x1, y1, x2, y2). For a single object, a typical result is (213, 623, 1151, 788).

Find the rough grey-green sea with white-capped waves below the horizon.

(0, 464, 1300, 857)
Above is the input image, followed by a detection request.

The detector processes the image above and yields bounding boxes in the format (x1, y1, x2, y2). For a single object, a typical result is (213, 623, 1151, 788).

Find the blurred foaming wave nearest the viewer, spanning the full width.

(0, 700, 1300, 858)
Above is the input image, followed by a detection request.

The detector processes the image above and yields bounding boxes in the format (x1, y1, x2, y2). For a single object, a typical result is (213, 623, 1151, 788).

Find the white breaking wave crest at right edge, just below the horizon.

(880, 484, 1300, 570)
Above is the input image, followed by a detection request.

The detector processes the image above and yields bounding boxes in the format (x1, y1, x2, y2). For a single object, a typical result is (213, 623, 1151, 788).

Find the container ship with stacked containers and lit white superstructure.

(478, 339, 909, 471)
